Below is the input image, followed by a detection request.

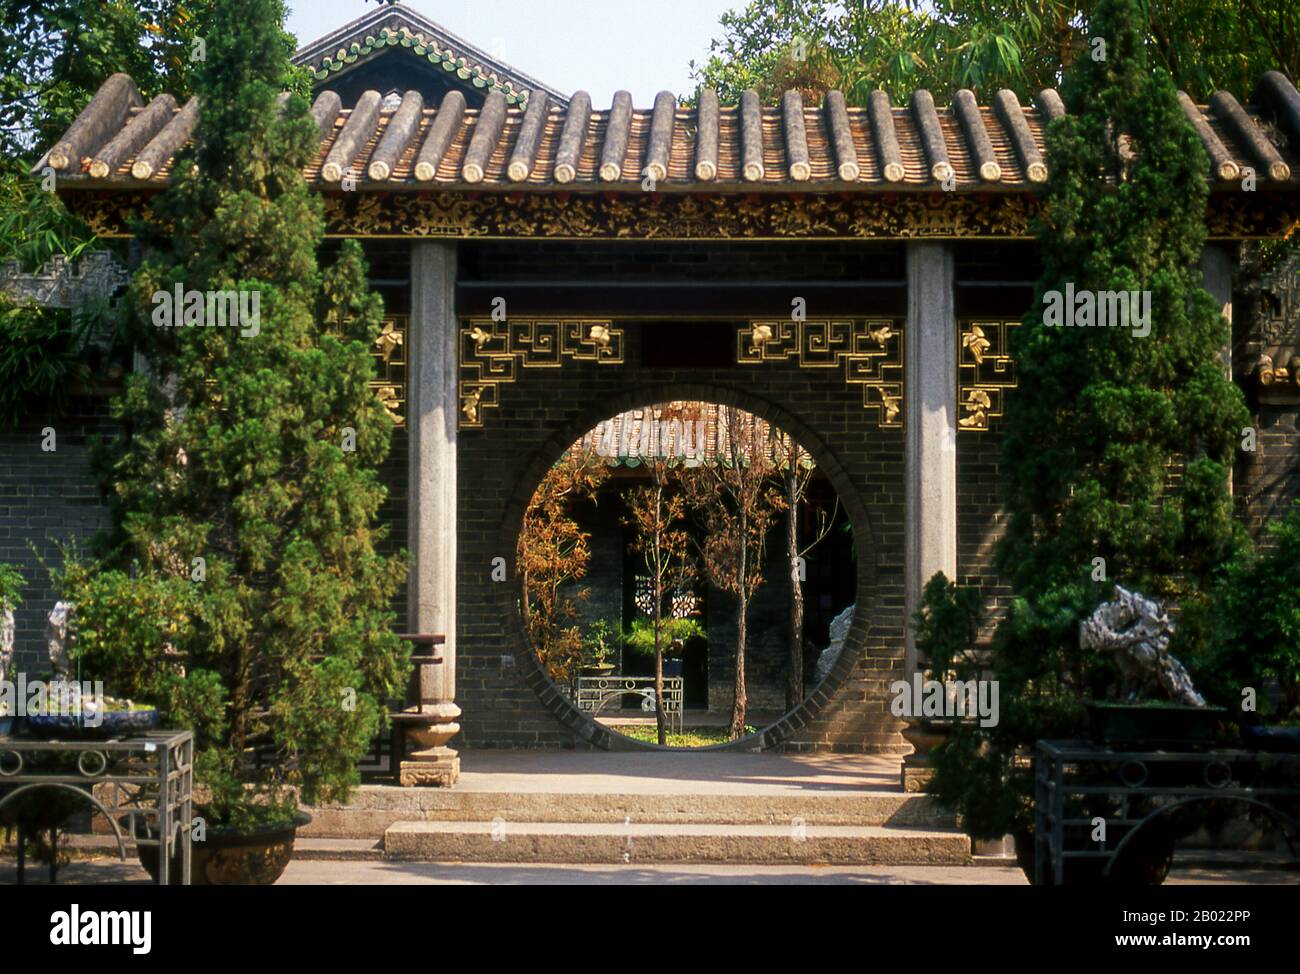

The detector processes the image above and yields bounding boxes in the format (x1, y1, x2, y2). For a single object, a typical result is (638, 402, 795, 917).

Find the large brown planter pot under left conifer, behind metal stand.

(139, 811, 312, 886)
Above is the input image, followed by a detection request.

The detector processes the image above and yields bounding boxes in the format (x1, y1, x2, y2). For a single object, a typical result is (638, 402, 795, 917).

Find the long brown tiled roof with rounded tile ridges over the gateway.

(34, 72, 1300, 192)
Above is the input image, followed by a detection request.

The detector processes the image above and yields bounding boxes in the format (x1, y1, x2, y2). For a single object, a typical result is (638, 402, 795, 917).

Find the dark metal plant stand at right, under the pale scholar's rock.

(1034, 741, 1300, 886)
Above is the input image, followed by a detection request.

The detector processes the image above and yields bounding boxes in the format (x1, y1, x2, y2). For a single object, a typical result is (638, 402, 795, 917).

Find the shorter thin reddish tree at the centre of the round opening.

(623, 458, 696, 744)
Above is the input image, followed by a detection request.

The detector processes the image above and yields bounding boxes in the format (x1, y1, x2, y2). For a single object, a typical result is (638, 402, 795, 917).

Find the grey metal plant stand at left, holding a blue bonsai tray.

(0, 731, 194, 886)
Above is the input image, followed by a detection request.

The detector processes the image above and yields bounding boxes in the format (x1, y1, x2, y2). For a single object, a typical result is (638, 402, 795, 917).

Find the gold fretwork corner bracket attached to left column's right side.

(459, 317, 623, 429)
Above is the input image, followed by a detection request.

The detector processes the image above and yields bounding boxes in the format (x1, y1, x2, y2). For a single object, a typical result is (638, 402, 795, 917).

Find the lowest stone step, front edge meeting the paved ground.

(384, 822, 971, 866)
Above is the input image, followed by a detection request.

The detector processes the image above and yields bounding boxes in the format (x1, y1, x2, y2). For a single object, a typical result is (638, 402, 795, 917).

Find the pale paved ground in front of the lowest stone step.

(0, 858, 1300, 886)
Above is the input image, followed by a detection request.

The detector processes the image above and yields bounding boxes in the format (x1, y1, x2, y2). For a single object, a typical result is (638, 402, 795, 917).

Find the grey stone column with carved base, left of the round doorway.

(400, 241, 460, 785)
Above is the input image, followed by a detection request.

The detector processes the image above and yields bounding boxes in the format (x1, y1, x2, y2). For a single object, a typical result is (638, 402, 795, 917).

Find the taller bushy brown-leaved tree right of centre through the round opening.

(681, 406, 785, 740)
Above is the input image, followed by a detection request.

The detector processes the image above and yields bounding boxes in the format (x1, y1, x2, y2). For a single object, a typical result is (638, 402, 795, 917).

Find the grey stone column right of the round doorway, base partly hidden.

(902, 242, 957, 791)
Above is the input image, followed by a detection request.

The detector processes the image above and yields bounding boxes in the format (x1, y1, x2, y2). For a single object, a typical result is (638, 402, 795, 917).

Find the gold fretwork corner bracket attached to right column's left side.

(736, 319, 902, 428)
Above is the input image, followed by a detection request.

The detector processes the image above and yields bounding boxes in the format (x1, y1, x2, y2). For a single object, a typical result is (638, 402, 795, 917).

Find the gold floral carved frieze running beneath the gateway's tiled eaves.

(62, 183, 1300, 241)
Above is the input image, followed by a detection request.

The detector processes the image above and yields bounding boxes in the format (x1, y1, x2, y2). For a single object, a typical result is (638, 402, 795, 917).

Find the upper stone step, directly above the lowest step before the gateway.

(299, 785, 954, 839)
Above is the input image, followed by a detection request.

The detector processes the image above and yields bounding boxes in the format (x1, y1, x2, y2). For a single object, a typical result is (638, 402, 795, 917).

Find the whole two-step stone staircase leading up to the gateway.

(295, 783, 971, 865)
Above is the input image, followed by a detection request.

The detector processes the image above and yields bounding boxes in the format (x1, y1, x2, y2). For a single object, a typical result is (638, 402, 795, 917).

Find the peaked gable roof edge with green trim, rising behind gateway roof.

(294, 4, 568, 107)
